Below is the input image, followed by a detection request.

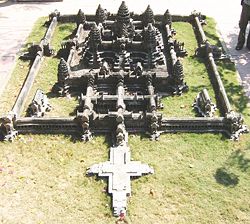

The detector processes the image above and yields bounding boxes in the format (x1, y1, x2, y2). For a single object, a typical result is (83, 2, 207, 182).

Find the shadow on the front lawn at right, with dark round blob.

(214, 150, 250, 187)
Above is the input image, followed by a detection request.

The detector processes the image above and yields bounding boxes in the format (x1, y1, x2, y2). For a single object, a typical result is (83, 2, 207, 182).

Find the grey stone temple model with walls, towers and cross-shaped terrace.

(0, 1, 248, 216)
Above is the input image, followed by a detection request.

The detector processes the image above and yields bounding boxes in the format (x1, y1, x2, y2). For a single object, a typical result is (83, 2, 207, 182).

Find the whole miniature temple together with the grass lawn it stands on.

(0, 2, 249, 223)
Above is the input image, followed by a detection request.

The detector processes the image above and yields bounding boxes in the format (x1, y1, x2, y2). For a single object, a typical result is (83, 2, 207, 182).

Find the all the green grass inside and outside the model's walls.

(0, 16, 250, 224)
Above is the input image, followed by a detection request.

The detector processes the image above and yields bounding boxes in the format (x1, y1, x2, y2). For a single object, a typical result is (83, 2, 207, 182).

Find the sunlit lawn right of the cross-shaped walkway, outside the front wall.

(130, 134, 250, 223)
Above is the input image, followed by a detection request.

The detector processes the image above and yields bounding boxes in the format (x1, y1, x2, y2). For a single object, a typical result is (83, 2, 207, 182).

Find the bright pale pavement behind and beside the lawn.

(0, 0, 250, 99)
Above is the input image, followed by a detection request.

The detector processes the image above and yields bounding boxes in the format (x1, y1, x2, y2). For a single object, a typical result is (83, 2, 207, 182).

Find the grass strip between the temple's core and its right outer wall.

(163, 22, 218, 117)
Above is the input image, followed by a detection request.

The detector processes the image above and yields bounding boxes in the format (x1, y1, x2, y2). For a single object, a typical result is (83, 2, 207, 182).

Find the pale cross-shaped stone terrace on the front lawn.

(87, 145, 154, 216)
